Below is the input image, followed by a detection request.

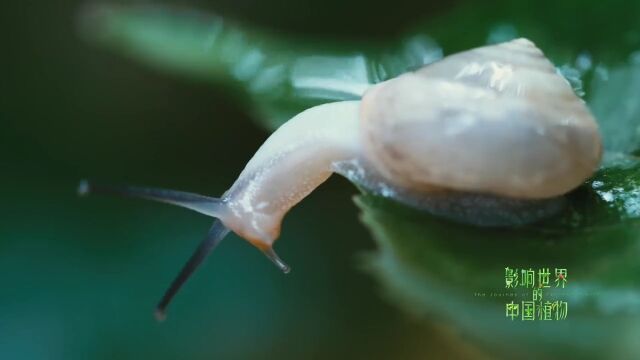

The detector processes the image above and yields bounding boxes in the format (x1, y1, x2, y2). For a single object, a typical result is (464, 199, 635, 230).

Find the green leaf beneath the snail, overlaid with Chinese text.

(357, 194, 640, 357)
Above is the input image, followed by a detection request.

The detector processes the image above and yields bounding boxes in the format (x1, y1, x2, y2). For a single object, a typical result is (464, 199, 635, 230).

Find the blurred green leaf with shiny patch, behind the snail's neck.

(81, 4, 442, 130)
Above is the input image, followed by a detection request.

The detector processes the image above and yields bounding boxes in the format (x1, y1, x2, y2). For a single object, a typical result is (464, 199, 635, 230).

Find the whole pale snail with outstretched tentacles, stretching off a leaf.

(79, 38, 602, 318)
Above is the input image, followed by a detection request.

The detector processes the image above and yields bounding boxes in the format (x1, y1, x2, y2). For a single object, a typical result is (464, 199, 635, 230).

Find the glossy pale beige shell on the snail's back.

(360, 39, 602, 199)
